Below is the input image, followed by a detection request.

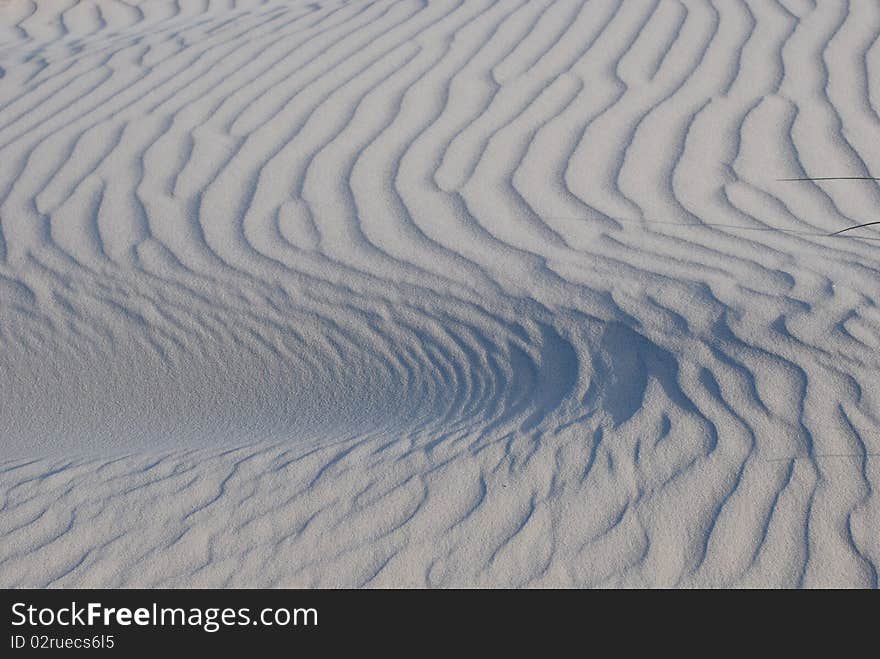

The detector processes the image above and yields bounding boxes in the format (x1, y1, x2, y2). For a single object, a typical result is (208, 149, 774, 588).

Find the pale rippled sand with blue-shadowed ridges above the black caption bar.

(0, 0, 880, 587)
